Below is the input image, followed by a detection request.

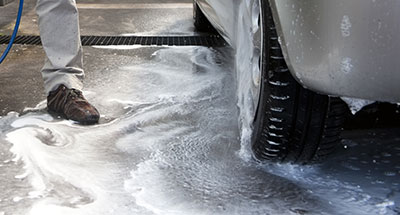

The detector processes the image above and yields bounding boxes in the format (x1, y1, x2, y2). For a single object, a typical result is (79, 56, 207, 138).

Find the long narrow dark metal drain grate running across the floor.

(0, 35, 226, 47)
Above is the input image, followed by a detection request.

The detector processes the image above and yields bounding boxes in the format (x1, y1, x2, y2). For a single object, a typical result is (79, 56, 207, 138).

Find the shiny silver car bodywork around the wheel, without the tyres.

(197, 0, 400, 102)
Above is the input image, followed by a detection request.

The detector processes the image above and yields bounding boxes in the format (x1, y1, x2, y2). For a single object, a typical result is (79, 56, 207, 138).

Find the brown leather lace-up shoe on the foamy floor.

(47, 85, 100, 124)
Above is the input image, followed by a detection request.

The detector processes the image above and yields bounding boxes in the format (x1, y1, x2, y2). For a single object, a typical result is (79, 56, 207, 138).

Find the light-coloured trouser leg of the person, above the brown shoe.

(36, 0, 84, 95)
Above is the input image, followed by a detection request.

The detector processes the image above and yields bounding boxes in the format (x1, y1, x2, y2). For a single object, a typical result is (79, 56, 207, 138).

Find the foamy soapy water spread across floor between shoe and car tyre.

(0, 47, 400, 214)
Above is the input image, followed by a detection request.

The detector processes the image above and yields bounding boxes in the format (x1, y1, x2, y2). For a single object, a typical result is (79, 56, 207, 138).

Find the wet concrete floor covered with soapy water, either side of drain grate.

(0, 1, 400, 214)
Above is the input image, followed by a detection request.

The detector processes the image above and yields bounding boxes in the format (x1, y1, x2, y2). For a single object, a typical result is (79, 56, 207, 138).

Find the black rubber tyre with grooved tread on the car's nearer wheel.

(251, 0, 346, 163)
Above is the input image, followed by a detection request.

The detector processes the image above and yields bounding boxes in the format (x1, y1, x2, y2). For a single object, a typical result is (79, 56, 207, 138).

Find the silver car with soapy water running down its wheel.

(193, 0, 400, 163)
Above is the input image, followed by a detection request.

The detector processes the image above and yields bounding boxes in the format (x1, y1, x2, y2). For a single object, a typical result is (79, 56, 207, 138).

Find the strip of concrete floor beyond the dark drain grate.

(0, 0, 194, 35)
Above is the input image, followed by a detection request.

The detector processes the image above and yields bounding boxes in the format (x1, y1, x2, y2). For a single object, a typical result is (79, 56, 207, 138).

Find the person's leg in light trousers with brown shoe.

(36, 0, 100, 124)
